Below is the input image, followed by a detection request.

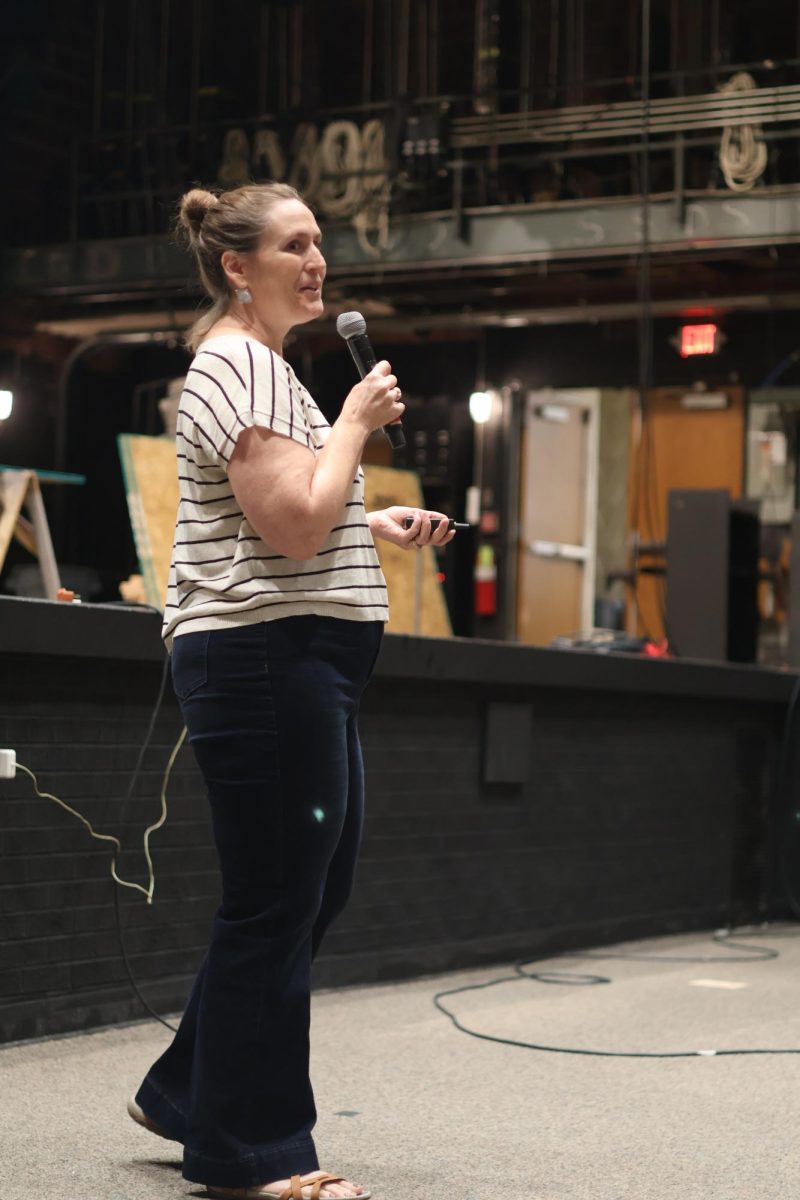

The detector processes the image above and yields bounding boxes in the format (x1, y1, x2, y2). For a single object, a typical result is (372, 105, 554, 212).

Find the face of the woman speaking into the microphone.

(242, 200, 325, 330)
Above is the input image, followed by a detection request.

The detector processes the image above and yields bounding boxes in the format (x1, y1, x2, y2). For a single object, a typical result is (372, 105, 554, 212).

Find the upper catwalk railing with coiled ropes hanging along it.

(61, 65, 800, 242)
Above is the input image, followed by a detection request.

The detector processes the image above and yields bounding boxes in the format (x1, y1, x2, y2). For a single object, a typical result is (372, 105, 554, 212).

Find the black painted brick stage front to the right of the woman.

(335, 678, 776, 979)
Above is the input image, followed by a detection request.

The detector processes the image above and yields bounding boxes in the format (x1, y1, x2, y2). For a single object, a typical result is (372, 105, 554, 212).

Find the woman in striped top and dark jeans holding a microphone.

(128, 184, 453, 1200)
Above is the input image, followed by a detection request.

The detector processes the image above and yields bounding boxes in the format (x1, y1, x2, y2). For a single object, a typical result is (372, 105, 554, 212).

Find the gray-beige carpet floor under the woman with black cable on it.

(0, 926, 800, 1200)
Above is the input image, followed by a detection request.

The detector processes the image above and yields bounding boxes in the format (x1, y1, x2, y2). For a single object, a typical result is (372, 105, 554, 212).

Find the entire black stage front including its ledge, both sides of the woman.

(0, 598, 798, 1042)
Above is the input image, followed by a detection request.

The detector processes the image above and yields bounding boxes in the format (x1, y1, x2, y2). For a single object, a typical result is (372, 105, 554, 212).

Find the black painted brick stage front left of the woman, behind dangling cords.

(0, 655, 217, 1039)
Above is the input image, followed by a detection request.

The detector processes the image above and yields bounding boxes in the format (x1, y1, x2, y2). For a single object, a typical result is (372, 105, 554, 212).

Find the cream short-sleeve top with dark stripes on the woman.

(163, 334, 389, 648)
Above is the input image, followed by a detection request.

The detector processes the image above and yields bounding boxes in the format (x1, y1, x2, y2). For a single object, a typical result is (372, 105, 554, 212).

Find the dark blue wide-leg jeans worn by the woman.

(137, 616, 383, 1187)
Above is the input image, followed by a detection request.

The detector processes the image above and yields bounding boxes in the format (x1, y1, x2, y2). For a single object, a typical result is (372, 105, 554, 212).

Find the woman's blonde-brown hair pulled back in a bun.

(175, 184, 306, 353)
